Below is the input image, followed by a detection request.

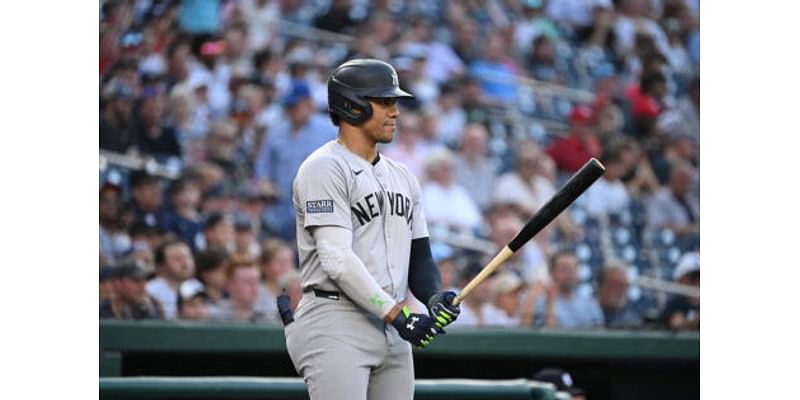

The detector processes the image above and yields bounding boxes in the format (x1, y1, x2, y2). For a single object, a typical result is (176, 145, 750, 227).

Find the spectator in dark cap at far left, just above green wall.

(100, 262, 164, 319)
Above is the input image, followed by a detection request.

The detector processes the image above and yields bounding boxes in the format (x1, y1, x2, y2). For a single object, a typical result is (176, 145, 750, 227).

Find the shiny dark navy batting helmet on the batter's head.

(328, 59, 414, 125)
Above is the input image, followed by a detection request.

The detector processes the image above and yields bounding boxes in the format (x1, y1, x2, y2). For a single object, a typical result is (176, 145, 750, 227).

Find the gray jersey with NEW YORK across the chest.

(294, 140, 428, 302)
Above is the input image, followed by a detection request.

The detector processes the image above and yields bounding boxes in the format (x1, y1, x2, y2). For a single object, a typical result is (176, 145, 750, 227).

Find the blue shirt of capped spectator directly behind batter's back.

(255, 115, 337, 241)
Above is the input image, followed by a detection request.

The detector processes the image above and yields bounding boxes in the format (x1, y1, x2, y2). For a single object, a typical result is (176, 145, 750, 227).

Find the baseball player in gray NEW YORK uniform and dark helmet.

(286, 59, 460, 400)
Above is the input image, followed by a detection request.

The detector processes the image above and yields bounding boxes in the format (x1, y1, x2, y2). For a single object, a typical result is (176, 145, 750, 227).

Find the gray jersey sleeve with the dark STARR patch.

(294, 157, 353, 229)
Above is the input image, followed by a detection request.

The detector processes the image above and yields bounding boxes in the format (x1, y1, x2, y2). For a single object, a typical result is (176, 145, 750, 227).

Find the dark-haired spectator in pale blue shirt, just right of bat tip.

(585, 144, 632, 218)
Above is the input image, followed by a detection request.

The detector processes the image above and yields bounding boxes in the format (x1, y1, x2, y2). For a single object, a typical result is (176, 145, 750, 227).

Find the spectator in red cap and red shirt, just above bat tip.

(547, 106, 603, 173)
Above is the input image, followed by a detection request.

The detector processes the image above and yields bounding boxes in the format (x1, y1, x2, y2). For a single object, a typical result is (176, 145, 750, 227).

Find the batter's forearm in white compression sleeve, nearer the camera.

(314, 226, 397, 319)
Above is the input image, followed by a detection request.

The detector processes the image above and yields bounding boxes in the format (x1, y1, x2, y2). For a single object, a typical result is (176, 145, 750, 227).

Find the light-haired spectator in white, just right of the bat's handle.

(484, 272, 523, 327)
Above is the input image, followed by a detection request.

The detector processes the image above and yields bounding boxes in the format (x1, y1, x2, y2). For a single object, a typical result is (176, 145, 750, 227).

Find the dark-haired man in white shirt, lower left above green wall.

(146, 239, 194, 319)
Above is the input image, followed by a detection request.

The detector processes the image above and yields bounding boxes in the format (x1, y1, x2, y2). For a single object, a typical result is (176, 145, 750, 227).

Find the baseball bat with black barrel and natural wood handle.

(453, 158, 606, 305)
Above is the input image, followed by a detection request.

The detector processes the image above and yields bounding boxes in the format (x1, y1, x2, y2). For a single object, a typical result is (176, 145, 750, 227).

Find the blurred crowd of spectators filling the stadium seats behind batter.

(99, 0, 700, 329)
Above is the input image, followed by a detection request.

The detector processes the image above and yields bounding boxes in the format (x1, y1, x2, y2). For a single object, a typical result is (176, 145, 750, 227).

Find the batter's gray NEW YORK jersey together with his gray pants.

(285, 141, 428, 400)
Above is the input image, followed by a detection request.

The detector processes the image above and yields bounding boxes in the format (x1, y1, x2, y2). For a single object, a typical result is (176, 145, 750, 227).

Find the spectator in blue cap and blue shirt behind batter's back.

(255, 80, 336, 241)
